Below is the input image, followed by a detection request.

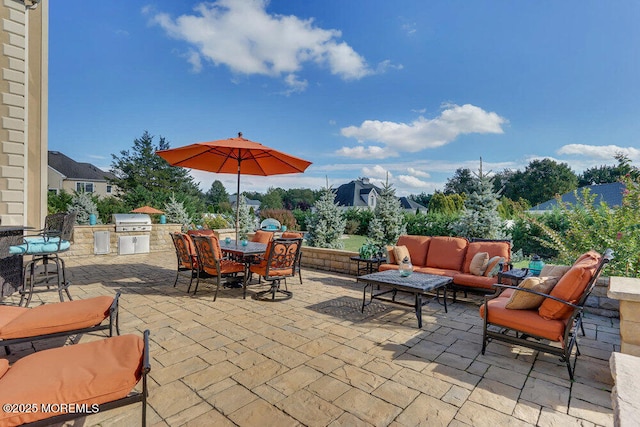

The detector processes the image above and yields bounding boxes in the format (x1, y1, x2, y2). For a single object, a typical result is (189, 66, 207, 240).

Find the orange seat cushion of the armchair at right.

(480, 292, 566, 341)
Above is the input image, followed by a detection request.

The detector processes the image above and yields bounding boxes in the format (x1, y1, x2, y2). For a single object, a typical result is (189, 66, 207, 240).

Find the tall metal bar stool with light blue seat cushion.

(9, 212, 76, 307)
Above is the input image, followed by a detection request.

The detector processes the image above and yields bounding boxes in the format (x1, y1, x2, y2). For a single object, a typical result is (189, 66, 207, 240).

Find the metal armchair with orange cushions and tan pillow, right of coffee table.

(480, 249, 613, 380)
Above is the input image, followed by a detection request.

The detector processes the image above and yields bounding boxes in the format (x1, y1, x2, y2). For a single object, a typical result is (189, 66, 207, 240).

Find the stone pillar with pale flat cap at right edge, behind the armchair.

(607, 276, 640, 356)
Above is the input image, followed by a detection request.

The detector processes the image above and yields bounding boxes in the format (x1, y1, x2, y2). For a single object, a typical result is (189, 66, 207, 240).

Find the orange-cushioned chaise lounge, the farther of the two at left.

(0, 292, 120, 354)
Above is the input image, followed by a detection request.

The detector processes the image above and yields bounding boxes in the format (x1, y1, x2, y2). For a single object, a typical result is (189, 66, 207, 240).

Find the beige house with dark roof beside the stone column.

(48, 151, 116, 197)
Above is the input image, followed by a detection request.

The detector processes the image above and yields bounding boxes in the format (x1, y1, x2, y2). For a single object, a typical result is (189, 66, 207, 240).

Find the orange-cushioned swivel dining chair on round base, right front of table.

(249, 239, 302, 301)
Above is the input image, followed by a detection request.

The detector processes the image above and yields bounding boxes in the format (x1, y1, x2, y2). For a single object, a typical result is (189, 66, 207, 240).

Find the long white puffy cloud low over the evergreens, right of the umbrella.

(341, 104, 507, 153)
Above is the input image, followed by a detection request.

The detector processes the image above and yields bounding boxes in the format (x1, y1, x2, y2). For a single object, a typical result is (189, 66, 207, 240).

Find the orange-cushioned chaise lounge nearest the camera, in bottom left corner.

(0, 331, 151, 426)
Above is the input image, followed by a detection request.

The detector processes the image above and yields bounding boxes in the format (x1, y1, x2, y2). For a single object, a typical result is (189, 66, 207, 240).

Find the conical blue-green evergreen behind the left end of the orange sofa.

(368, 179, 407, 250)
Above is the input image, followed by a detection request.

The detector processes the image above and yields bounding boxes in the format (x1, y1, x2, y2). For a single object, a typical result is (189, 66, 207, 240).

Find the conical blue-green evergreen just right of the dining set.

(307, 186, 346, 249)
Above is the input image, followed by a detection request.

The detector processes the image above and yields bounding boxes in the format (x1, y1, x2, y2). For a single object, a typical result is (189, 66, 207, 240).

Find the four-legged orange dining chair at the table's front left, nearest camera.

(192, 235, 247, 301)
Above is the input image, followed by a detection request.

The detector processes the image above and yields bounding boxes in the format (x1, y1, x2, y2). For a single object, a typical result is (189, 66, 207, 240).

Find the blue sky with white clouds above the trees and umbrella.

(49, 0, 640, 195)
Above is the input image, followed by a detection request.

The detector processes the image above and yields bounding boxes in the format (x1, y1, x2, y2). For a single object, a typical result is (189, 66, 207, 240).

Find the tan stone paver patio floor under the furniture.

(6, 252, 619, 427)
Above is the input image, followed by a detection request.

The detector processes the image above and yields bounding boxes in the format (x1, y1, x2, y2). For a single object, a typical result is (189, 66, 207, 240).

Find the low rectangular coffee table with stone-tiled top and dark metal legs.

(357, 270, 451, 328)
